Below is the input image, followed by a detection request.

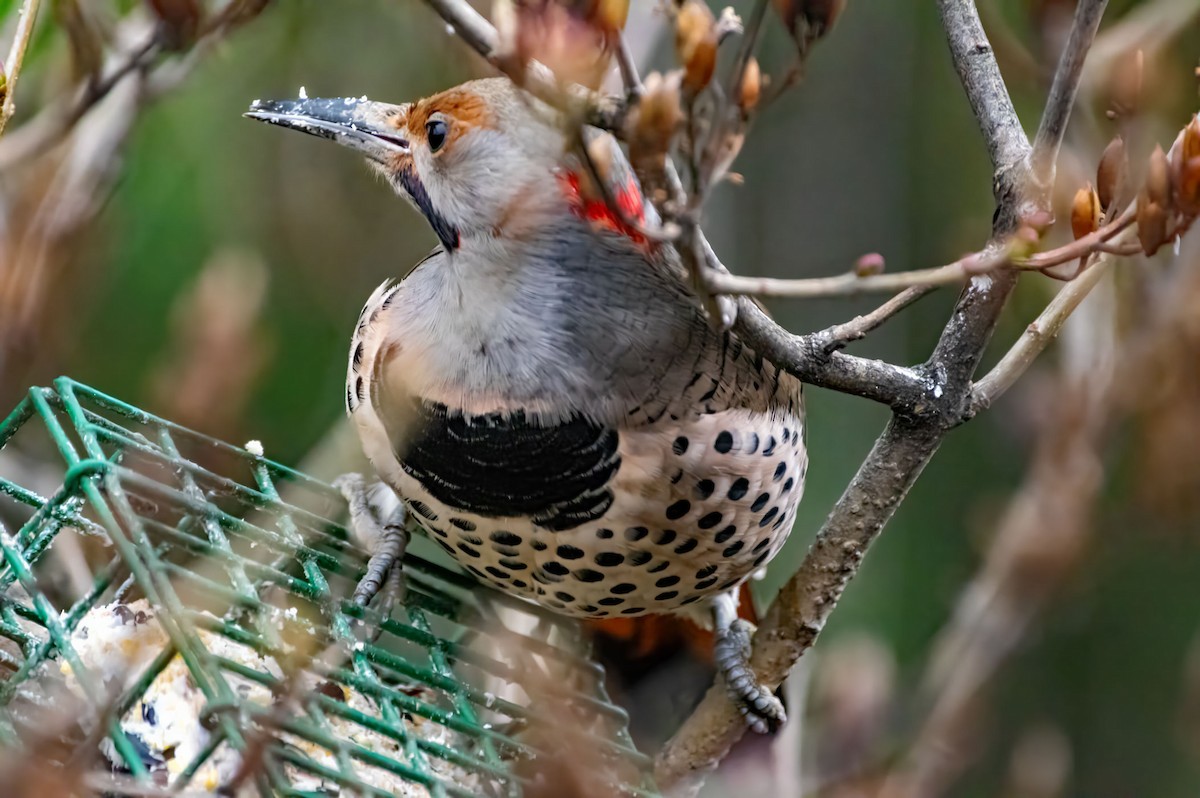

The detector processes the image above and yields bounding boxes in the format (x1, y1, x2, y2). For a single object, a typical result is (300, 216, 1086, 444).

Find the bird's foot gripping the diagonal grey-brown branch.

(713, 593, 787, 734)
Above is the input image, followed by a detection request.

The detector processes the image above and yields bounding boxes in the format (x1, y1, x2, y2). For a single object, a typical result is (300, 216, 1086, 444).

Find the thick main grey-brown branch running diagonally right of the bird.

(655, 0, 1056, 782)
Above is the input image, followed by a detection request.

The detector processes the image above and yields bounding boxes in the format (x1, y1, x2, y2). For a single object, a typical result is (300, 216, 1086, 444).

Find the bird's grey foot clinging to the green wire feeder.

(334, 474, 409, 618)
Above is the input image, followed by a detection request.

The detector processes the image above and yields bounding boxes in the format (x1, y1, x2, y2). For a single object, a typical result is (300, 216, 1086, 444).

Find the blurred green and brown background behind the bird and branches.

(0, 0, 1200, 797)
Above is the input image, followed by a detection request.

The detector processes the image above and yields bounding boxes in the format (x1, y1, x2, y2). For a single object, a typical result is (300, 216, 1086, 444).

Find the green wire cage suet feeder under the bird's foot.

(0, 378, 655, 797)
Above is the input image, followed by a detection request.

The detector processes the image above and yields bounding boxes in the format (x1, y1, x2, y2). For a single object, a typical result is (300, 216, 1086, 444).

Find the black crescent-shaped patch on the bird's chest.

(396, 402, 620, 532)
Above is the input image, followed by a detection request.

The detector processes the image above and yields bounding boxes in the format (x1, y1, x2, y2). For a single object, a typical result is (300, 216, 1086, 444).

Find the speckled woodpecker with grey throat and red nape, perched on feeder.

(246, 77, 808, 731)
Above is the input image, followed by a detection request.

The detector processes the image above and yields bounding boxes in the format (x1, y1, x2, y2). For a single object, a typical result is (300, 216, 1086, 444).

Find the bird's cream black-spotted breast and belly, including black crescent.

(347, 264, 808, 618)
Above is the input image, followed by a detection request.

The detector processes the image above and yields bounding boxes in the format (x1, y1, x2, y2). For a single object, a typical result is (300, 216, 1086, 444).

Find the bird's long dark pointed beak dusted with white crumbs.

(245, 97, 409, 163)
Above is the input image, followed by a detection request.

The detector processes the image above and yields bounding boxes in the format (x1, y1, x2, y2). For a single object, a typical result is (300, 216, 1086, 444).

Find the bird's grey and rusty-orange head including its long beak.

(246, 78, 641, 251)
